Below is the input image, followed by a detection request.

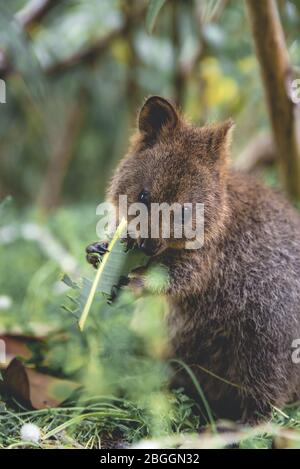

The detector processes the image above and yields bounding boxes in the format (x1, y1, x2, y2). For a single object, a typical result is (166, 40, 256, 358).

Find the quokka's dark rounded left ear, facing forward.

(138, 96, 179, 142)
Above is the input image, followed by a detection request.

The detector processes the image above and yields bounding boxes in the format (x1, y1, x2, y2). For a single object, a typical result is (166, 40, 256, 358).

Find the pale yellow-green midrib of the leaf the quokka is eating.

(78, 218, 127, 331)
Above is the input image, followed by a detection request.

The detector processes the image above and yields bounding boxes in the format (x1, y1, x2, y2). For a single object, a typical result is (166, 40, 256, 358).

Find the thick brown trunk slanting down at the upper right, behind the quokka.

(246, 0, 300, 200)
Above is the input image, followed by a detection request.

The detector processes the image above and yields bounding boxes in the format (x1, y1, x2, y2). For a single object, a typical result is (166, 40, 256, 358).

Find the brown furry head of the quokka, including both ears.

(108, 96, 233, 256)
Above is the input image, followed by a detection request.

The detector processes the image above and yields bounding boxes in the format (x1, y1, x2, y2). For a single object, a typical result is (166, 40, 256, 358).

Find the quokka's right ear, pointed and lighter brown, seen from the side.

(203, 119, 235, 159)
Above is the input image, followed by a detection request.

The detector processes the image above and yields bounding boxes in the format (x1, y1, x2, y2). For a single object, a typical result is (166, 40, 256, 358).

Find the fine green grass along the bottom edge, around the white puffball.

(0, 396, 300, 449)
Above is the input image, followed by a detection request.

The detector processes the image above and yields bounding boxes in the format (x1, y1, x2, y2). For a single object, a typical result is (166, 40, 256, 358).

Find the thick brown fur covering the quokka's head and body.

(102, 97, 300, 421)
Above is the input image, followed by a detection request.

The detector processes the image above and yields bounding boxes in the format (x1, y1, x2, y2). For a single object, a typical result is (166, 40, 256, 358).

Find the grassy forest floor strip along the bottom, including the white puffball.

(0, 396, 300, 449)
